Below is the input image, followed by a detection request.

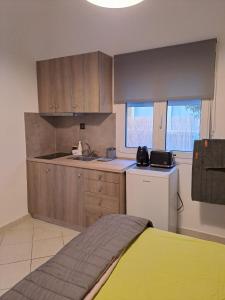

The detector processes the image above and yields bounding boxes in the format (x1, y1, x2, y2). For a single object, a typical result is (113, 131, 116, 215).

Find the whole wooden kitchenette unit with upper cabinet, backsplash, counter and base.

(25, 52, 135, 231)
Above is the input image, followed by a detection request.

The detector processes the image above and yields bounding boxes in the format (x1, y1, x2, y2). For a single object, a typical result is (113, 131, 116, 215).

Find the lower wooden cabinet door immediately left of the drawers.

(54, 166, 83, 226)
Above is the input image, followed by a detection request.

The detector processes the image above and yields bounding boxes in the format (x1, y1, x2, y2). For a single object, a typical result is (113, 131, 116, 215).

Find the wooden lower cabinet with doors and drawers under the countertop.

(27, 161, 125, 230)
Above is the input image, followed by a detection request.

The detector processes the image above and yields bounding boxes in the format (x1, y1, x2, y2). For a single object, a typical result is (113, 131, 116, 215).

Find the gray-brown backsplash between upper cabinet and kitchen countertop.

(25, 113, 116, 157)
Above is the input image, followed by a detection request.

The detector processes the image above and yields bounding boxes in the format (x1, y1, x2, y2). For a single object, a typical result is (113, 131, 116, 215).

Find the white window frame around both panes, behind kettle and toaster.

(114, 100, 212, 163)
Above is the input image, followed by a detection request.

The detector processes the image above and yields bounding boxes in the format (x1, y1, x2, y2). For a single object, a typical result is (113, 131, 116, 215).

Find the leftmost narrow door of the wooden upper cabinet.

(37, 60, 55, 112)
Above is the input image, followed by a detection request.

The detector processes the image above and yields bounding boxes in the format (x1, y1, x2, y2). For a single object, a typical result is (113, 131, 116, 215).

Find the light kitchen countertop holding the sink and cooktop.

(27, 155, 135, 173)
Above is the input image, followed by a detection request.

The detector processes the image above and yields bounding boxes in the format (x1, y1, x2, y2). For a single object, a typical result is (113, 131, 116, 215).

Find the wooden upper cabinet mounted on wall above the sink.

(37, 52, 112, 113)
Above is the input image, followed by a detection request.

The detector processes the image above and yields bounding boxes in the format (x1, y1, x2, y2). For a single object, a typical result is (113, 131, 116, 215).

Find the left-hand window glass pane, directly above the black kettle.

(126, 102, 153, 148)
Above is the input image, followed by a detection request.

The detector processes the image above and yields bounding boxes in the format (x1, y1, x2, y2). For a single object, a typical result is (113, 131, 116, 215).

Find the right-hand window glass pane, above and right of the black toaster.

(166, 100, 201, 151)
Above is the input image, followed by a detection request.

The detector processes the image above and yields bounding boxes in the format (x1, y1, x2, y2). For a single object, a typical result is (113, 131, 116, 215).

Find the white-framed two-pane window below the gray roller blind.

(118, 99, 212, 158)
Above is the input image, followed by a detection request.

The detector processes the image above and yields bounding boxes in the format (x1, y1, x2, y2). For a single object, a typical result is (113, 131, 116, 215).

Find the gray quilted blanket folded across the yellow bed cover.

(0, 215, 152, 300)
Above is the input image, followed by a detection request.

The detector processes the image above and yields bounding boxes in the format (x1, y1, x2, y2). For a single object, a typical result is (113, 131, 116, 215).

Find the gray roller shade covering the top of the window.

(114, 39, 217, 104)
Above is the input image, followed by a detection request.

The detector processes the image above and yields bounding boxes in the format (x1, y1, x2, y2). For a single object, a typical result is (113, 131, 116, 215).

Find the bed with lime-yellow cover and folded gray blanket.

(1, 215, 225, 300)
